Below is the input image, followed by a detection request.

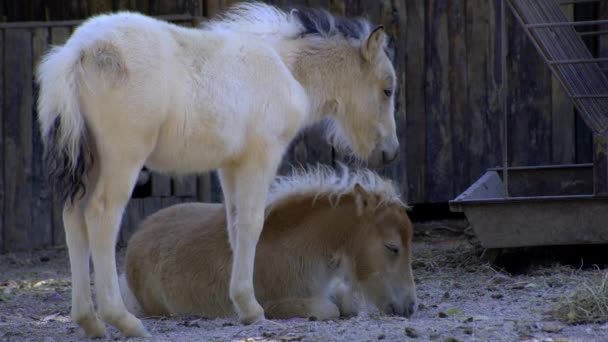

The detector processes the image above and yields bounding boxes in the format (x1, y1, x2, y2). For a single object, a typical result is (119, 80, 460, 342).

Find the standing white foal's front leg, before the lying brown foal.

(223, 158, 280, 324)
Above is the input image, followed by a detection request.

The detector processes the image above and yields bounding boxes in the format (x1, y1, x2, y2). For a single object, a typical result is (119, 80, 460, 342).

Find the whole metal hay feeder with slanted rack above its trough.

(450, 0, 608, 248)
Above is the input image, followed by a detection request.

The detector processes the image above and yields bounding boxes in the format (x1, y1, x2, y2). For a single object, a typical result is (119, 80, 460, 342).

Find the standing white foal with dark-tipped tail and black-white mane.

(37, 3, 399, 337)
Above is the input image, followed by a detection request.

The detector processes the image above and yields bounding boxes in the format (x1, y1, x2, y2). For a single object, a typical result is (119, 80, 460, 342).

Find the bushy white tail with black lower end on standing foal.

(36, 44, 93, 202)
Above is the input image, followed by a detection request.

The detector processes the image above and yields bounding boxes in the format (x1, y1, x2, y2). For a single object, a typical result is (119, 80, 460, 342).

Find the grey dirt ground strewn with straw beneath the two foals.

(0, 221, 608, 342)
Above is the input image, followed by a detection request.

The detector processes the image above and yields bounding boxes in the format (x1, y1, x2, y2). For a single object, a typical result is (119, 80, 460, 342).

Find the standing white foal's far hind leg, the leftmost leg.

(63, 200, 105, 337)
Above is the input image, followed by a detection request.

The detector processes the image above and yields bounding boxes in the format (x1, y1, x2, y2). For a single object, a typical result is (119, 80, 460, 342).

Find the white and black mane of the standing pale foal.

(202, 2, 371, 41)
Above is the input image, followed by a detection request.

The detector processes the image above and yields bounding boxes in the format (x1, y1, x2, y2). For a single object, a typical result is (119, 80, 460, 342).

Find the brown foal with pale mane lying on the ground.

(121, 168, 416, 319)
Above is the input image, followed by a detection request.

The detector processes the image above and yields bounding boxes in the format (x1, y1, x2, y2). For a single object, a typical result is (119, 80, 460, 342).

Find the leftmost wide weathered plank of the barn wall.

(3, 29, 33, 251)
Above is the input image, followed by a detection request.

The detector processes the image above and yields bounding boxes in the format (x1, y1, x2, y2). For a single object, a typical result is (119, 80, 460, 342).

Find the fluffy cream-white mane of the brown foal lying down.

(266, 164, 407, 215)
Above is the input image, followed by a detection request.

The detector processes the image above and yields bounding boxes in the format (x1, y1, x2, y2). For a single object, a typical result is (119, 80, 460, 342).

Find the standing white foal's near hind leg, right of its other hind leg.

(85, 153, 149, 336)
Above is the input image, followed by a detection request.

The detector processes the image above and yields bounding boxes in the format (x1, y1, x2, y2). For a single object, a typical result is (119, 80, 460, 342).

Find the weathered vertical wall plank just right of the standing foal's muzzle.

(402, 1, 427, 203)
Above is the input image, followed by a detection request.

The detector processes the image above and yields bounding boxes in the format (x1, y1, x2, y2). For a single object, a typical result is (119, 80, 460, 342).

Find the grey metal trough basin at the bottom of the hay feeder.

(450, 164, 608, 248)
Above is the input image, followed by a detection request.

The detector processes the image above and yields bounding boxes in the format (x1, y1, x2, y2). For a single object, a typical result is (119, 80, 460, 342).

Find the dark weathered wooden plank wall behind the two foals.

(0, 0, 608, 252)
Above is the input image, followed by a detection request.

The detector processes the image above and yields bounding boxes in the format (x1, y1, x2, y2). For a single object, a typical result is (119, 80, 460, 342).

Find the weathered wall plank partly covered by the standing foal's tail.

(31, 28, 53, 246)
